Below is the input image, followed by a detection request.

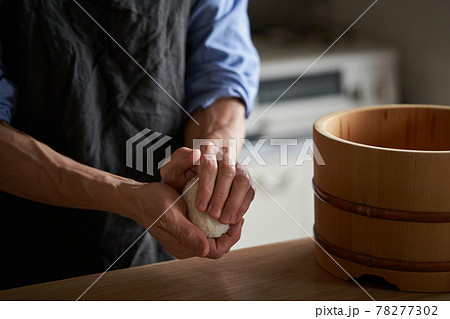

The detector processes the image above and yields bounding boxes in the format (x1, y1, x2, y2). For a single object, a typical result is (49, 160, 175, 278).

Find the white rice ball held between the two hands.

(183, 176, 230, 238)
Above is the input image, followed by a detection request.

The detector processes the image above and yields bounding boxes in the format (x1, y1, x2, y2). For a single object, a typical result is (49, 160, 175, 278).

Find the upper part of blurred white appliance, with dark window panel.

(247, 39, 399, 137)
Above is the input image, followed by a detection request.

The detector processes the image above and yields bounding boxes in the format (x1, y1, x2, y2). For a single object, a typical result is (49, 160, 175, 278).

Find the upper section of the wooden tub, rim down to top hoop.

(313, 105, 450, 212)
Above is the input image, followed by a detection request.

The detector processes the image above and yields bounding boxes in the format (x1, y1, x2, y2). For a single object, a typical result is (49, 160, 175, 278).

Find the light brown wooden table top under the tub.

(0, 238, 450, 300)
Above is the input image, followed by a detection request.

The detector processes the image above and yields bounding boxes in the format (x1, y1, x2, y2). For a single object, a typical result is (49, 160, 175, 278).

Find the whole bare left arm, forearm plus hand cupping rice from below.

(0, 122, 242, 258)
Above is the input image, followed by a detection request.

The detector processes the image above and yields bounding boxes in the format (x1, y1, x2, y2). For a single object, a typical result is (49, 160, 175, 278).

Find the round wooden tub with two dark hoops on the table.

(313, 105, 450, 292)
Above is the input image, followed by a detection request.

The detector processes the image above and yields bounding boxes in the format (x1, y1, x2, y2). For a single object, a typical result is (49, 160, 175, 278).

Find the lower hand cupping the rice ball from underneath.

(130, 183, 243, 259)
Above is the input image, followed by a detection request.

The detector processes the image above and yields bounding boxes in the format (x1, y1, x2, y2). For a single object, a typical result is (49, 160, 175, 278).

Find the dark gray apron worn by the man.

(0, 0, 190, 288)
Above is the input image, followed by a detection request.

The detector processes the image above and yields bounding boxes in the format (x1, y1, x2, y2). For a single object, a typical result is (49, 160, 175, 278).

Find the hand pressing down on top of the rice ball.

(161, 143, 255, 224)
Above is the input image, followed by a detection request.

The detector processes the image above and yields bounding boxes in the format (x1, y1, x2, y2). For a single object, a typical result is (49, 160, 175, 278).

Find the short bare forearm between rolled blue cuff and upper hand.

(184, 98, 245, 153)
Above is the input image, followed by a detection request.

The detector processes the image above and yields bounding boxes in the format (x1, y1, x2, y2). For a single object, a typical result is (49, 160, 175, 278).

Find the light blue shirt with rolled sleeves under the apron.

(0, 0, 259, 123)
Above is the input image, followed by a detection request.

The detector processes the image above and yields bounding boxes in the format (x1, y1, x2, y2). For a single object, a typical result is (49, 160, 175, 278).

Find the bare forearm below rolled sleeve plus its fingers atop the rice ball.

(185, 98, 255, 225)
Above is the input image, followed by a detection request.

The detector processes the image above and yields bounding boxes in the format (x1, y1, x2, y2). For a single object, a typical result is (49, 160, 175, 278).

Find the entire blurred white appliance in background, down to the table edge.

(233, 41, 399, 249)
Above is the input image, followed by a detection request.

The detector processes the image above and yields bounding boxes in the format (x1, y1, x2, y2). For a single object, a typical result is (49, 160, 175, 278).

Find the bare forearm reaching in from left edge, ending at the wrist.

(0, 122, 140, 224)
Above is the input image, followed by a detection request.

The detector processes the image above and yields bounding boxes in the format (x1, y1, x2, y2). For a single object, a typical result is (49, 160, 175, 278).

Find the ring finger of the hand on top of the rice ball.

(219, 167, 251, 224)
